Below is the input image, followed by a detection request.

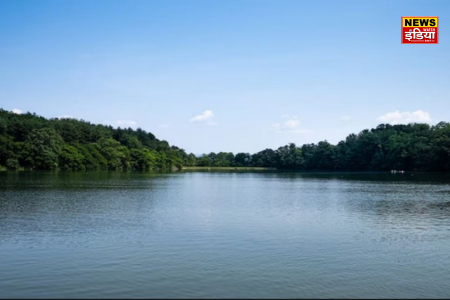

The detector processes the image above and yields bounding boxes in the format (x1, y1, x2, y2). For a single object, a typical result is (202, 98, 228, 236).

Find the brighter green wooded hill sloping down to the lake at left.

(0, 109, 195, 171)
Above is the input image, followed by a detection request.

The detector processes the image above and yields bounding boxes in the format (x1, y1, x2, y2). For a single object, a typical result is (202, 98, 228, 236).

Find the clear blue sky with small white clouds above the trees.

(0, 0, 450, 154)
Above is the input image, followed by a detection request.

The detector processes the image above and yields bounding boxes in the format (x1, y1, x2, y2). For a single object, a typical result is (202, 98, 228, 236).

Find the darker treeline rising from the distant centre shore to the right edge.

(196, 122, 450, 171)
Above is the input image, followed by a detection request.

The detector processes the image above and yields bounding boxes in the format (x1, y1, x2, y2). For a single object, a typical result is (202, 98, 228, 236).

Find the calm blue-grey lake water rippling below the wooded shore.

(0, 172, 450, 298)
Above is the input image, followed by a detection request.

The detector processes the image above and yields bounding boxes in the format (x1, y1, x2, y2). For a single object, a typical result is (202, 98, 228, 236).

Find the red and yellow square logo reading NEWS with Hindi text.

(402, 17, 438, 44)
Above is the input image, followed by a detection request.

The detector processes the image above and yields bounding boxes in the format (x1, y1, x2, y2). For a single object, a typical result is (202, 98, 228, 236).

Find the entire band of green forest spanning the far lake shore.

(0, 109, 450, 172)
